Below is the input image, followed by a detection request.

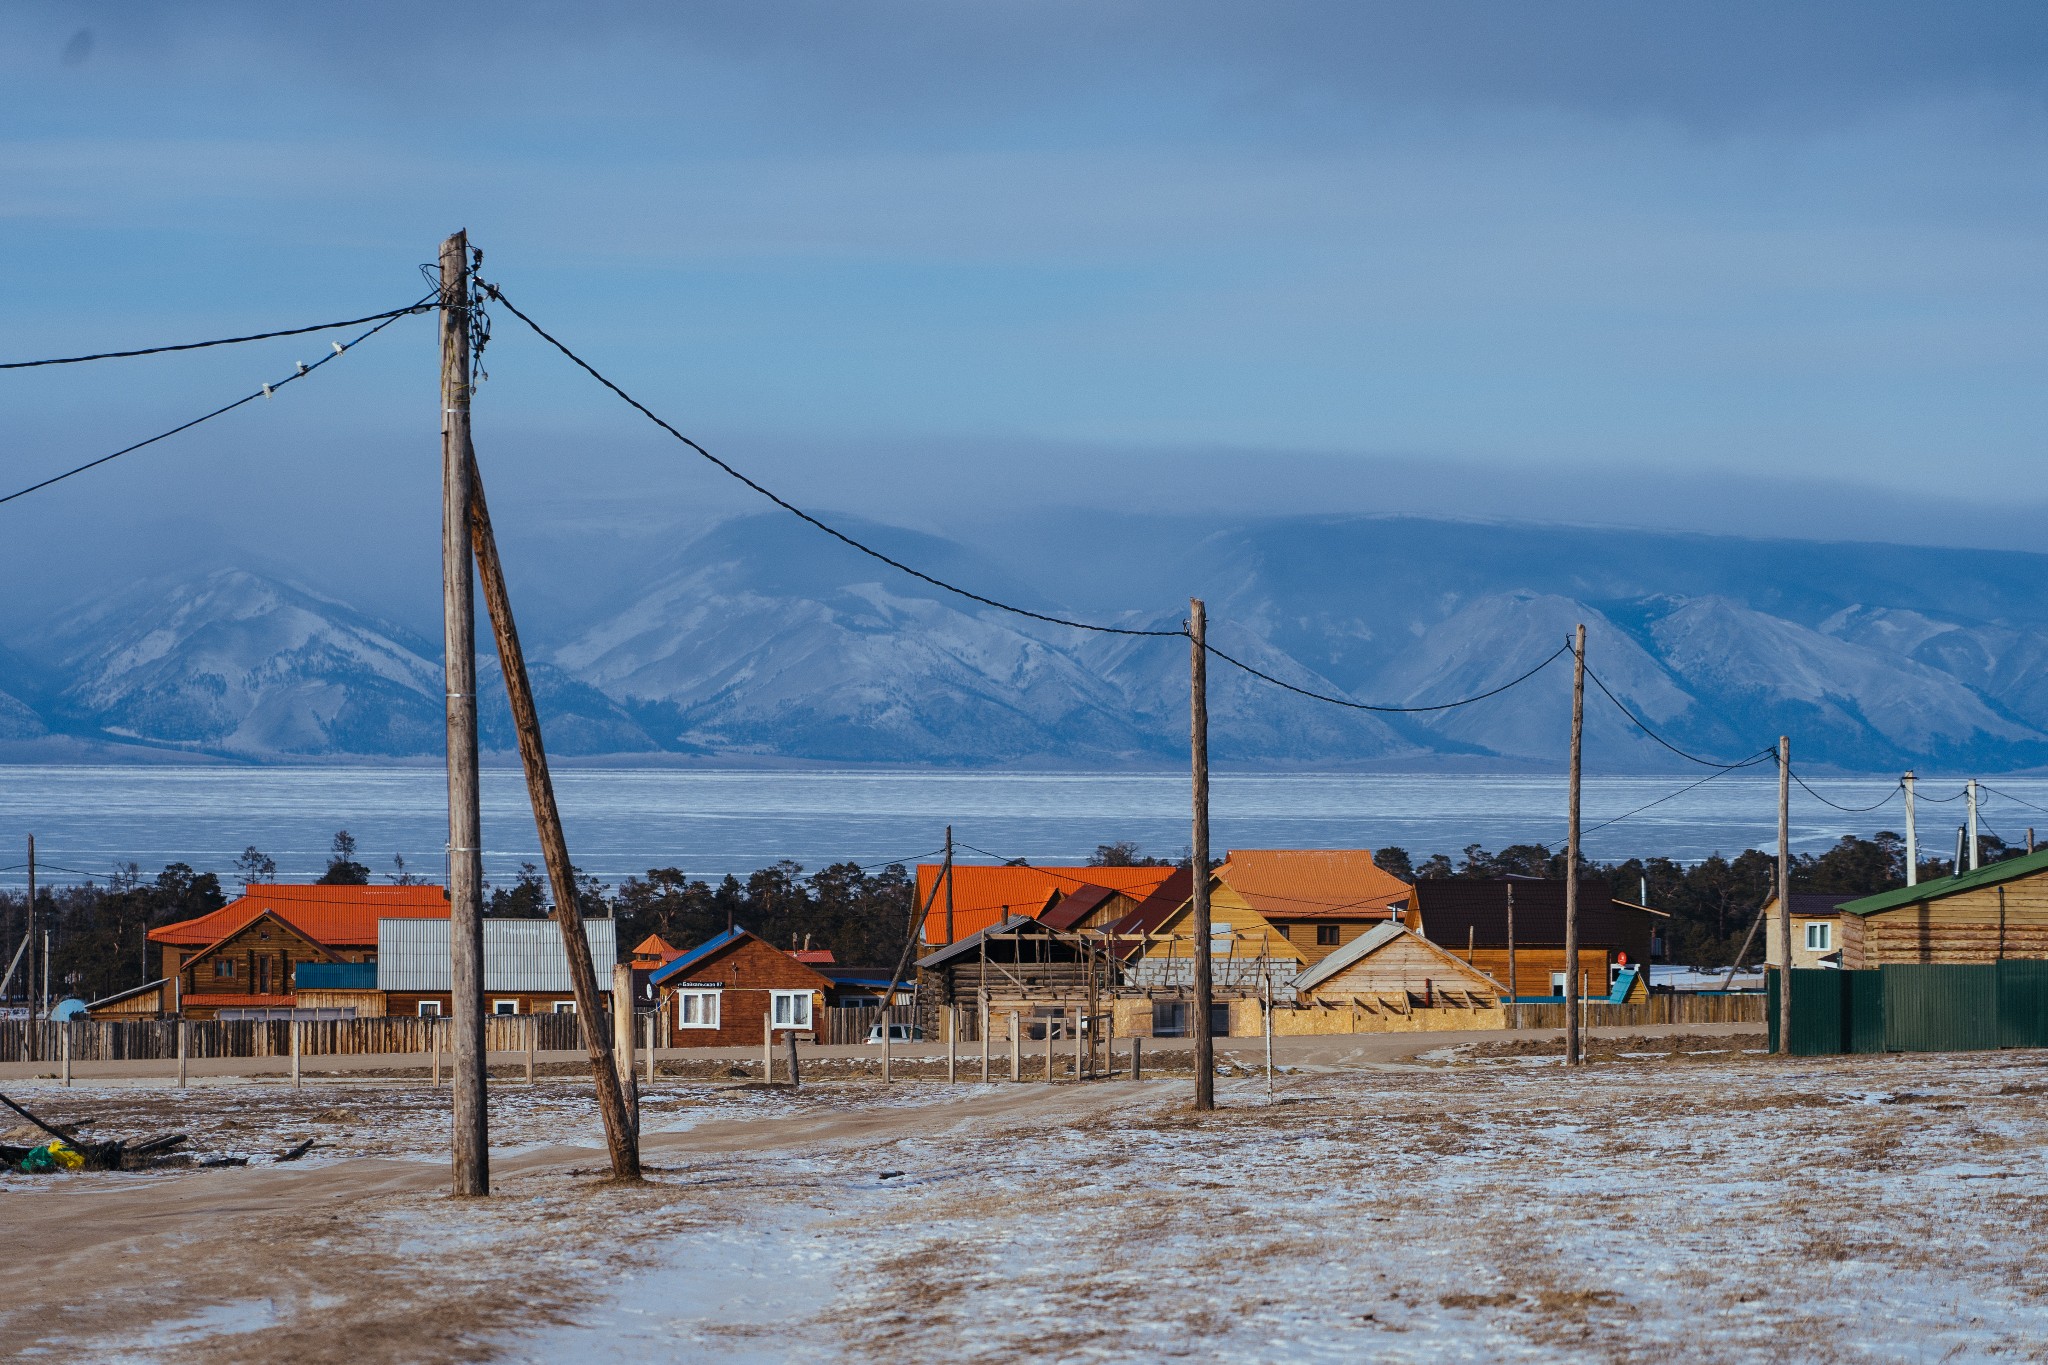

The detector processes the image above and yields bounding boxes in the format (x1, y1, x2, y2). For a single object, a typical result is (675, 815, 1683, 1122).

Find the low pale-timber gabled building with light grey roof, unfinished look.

(1274, 919, 1507, 1033)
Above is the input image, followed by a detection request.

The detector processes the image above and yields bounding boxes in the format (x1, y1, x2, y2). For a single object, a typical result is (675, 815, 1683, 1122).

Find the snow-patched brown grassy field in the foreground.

(0, 1040, 2048, 1361)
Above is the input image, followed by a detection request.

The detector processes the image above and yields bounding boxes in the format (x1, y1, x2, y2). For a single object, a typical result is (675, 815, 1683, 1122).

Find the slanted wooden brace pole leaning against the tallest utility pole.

(469, 452, 641, 1181)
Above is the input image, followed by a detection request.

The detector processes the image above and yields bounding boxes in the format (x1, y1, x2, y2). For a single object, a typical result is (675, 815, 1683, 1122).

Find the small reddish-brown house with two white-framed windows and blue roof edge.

(649, 925, 836, 1048)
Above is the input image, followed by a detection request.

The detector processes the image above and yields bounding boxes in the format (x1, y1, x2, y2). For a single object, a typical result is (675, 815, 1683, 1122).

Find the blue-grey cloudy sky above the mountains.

(0, 0, 2048, 618)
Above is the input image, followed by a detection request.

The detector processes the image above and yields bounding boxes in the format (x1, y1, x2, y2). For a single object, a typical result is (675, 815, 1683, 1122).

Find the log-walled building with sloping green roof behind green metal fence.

(1835, 849, 2048, 970)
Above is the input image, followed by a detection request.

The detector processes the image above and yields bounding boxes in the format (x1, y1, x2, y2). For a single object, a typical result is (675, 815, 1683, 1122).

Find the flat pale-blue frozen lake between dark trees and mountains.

(0, 765, 2048, 886)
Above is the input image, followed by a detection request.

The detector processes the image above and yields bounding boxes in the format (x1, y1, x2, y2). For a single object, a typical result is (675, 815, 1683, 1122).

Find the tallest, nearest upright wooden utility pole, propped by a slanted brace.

(440, 233, 492, 1195)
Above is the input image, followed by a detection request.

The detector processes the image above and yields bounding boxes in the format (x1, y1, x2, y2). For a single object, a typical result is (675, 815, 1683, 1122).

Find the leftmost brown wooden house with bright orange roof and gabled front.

(136, 884, 449, 1019)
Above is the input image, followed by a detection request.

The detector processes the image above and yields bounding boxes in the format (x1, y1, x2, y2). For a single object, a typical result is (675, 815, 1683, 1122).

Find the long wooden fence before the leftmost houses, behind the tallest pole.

(0, 1015, 584, 1062)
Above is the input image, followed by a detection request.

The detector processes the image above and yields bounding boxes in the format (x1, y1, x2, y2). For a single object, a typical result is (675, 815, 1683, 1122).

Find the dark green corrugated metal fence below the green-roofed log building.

(1765, 960, 2048, 1056)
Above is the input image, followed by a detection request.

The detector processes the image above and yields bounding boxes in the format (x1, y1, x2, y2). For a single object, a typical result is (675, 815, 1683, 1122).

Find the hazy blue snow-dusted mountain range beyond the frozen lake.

(0, 516, 2048, 772)
